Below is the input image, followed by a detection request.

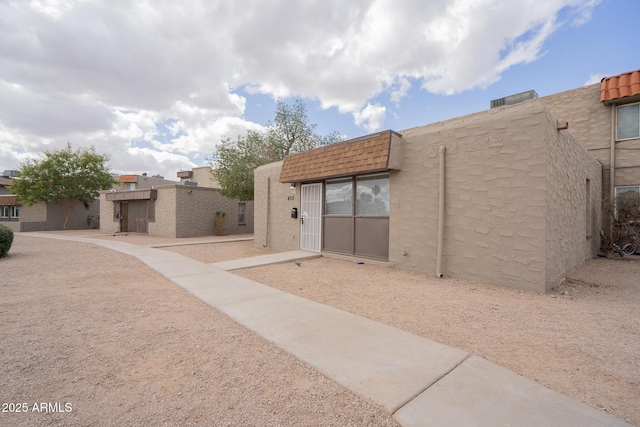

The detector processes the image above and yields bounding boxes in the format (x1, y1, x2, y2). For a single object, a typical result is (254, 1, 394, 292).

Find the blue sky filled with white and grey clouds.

(0, 0, 640, 179)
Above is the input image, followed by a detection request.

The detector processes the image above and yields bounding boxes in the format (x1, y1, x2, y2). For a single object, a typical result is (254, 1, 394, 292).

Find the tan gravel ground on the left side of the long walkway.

(0, 235, 397, 427)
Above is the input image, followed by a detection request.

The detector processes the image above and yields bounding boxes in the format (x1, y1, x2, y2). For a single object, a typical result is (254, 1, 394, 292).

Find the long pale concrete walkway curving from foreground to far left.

(20, 233, 629, 427)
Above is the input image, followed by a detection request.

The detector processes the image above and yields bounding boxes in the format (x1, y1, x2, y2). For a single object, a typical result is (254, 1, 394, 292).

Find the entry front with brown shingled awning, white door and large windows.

(280, 131, 401, 261)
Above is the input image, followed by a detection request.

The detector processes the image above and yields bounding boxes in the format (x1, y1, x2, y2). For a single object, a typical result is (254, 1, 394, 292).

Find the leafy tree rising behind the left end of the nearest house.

(212, 99, 340, 200)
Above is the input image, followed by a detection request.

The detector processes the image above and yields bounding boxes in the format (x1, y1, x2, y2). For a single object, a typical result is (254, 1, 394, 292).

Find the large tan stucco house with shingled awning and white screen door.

(255, 67, 640, 292)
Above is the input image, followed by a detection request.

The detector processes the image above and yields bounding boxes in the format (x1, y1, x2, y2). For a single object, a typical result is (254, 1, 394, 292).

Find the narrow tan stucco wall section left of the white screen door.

(254, 162, 300, 251)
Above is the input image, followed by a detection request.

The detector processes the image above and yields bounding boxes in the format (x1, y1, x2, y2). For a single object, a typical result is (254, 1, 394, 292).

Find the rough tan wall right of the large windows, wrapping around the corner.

(389, 100, 600, 292)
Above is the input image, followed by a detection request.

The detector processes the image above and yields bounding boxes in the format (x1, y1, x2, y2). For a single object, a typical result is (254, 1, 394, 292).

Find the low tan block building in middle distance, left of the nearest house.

(100, 167, 253, 238)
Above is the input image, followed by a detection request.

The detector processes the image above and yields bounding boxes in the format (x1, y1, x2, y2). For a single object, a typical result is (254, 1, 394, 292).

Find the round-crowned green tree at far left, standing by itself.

(11, 144, 115, 230)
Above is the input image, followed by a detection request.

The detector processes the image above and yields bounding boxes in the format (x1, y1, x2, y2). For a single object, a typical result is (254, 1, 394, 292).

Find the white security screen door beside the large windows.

(300, 183, 322, 252)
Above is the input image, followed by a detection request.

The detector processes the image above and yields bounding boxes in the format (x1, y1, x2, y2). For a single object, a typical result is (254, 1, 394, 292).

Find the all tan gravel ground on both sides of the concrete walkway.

(0, 235, 640, 426)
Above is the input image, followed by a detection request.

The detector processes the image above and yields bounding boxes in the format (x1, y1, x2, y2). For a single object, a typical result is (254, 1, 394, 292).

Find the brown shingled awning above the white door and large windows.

(280, 130, 400, 182)
